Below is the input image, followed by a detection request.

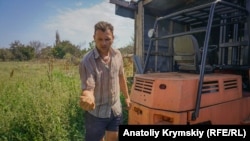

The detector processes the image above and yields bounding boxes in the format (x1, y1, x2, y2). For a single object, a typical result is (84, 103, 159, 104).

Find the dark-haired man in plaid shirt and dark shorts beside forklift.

(79, 21, 130, 141)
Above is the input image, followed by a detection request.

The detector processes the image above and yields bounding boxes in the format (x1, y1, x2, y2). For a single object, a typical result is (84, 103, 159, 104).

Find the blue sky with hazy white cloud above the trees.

(0, 0, 134, 49)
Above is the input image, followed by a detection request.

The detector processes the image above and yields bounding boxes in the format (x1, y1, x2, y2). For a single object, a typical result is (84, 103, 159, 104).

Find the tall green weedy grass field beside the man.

(0, 61, 133, 141)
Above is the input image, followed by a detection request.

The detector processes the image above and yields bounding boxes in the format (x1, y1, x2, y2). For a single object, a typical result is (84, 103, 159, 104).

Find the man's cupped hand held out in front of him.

(80, 91, 95, 111)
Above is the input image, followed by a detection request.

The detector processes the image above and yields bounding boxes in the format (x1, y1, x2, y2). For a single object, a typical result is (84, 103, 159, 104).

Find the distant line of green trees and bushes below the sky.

(0, 32, 133, 61)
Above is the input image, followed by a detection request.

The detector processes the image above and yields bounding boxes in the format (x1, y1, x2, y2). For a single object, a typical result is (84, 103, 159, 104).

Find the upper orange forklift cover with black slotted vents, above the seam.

(131, 72, 242, 112)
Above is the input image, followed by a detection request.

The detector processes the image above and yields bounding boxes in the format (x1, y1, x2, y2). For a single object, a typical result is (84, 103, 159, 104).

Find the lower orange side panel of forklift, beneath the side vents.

(188, 97, 250, 124)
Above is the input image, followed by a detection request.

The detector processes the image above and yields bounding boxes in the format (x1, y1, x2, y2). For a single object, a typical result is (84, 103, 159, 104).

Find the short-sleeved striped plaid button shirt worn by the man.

(79, 48, 124, 118)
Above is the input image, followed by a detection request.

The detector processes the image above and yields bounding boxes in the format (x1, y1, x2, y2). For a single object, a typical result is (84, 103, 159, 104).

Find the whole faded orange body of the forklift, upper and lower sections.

(129, 72, 250, 124)
